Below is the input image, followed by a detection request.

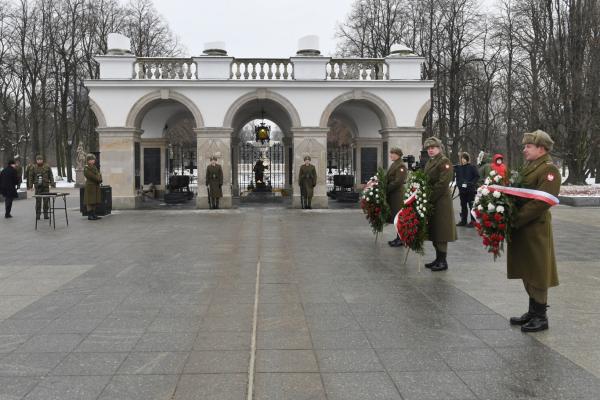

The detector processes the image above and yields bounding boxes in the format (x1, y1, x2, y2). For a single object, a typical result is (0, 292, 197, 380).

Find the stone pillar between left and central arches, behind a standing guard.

(194, 127, 233, 208)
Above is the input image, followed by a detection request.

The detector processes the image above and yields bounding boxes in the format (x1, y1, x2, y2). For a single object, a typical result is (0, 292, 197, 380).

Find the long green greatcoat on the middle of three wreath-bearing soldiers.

(425, 153, 456, 242)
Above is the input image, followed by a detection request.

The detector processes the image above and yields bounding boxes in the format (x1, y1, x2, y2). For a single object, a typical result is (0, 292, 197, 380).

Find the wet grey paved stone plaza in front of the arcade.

(0, 192, 600, 400)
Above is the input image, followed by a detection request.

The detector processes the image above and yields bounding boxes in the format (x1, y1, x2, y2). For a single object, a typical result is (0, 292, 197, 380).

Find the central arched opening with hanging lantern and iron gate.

(230, 97, 294, 204)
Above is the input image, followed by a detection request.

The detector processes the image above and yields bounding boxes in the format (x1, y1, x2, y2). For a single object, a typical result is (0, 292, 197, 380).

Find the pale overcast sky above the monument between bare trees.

(154, 0, 353, 58)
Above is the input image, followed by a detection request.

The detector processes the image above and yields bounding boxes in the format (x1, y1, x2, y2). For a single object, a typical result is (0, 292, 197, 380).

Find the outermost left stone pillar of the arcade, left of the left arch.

(97, 128, 142, 209)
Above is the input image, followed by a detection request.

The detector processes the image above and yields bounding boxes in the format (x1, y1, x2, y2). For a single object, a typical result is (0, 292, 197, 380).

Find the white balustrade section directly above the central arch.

(231, 58, 293, 80)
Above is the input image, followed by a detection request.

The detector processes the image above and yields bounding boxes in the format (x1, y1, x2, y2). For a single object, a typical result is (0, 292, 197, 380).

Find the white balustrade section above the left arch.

(133, 57, 196, 79)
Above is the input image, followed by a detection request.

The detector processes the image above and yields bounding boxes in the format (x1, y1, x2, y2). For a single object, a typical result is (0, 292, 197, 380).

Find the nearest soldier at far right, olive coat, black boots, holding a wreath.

(506, 130, 561, 332)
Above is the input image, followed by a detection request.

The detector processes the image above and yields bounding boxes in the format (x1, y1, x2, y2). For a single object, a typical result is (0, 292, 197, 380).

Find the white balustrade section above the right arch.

(327, 58, 388, 81)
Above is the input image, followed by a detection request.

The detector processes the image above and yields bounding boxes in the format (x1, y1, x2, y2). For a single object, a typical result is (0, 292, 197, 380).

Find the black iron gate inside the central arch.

(238, 142, 285, 193)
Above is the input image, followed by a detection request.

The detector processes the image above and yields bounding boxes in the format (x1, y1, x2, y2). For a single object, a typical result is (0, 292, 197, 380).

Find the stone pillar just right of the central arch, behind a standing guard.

(292, 128, 329, 208)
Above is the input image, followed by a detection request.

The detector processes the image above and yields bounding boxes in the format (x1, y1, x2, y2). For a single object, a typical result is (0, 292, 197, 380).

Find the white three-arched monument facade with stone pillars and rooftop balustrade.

(86, 39, 433, 209)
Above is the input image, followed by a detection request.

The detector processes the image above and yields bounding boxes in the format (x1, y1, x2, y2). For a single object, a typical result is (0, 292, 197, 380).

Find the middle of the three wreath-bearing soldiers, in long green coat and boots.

(423, 137, 456, 271)
